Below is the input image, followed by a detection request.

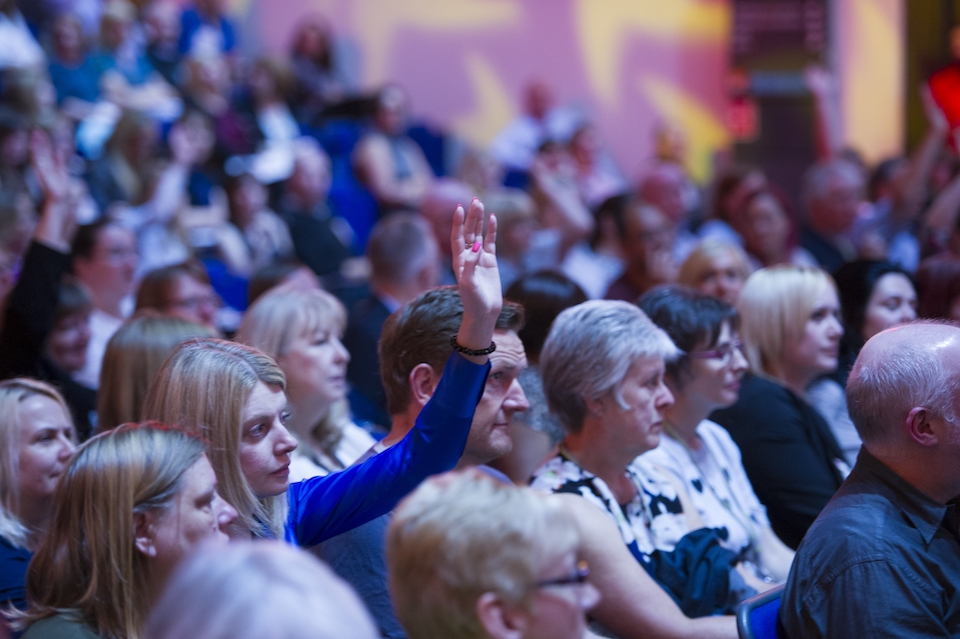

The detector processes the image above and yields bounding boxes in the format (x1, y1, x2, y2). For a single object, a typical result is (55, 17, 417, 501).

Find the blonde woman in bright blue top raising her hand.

(145, 200, 503, 546)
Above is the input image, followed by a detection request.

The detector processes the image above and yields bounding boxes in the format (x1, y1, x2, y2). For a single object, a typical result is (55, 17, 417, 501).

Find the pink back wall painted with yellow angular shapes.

(231, 0, 730, 185)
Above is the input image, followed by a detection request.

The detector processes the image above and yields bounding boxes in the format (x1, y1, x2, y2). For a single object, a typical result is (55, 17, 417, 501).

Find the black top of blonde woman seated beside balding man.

(710, 373, 843, 548)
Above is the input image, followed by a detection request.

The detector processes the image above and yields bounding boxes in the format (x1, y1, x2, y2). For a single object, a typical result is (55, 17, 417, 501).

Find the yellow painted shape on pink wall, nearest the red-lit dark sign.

(640, 75, 730, 183)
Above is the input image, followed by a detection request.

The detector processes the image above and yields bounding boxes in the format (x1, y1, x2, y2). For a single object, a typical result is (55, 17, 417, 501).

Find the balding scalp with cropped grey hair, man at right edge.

(847, 322, 960, 454)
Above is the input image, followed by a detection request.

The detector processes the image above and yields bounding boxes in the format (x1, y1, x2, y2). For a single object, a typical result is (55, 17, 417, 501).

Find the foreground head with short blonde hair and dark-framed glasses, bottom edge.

(386, 471, 599, 639)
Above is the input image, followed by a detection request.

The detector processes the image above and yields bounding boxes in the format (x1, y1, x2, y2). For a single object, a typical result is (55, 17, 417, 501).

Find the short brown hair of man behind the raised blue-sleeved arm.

(379, 286, 523, 415)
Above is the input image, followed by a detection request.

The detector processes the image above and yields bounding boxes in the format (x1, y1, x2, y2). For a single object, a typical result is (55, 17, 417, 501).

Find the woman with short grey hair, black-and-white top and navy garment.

(532, 300, 753, 617)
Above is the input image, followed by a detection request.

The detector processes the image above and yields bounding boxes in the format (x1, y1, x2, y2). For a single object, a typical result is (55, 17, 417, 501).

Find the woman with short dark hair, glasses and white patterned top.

(637, 286, 793, 583)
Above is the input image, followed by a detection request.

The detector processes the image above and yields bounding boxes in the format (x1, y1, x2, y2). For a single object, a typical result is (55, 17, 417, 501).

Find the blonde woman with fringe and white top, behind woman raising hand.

(236, 290, 375, 481)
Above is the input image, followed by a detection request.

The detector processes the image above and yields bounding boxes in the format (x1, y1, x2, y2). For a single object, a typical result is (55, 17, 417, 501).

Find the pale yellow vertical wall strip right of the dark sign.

(839, 0, 904, 163)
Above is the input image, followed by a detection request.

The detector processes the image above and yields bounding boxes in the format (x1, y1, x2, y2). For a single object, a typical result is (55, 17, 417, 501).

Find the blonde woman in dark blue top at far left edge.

(0, 378, 77, 608)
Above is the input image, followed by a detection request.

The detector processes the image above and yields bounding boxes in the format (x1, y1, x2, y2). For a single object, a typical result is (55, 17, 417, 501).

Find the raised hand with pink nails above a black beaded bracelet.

(450, 198, 503, 360)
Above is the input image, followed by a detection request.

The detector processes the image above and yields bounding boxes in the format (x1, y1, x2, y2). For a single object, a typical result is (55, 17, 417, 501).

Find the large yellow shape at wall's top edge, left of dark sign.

(574, 0, 731, 107)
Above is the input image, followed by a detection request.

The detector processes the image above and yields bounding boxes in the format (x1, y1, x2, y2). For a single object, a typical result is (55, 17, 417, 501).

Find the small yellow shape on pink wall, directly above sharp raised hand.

(451, 53, 517, 148)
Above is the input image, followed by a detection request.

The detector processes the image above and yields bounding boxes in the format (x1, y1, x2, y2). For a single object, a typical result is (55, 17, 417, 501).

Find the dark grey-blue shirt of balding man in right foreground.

(780, 449, 960, 639)
